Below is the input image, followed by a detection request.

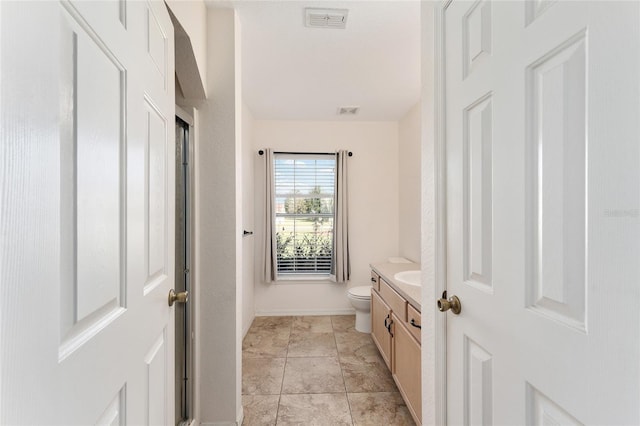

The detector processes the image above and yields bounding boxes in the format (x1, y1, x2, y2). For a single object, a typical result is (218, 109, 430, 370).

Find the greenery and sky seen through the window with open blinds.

(274, 154, 336, 276)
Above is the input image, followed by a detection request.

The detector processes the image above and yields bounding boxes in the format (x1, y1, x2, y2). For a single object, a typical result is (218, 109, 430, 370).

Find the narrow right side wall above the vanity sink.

(398, 103, 422, 262)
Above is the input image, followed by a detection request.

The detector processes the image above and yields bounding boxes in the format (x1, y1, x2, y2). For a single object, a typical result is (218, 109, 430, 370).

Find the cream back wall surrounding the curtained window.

(253, 120, 399, 315)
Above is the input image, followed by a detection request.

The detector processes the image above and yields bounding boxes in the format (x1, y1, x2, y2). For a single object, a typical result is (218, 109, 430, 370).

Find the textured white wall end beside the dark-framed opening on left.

(194, 9, 242, 425)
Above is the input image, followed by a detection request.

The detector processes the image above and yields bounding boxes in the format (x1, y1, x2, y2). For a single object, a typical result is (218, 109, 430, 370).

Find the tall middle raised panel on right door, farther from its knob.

(525, 29, 589, 333)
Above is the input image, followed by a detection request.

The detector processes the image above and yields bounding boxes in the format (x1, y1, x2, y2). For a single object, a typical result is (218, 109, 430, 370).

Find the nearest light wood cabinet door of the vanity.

(391, 315, 422, 424)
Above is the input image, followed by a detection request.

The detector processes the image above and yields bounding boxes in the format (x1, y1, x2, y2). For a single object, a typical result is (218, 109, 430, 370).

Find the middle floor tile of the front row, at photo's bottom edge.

(277, 393, 352, 426)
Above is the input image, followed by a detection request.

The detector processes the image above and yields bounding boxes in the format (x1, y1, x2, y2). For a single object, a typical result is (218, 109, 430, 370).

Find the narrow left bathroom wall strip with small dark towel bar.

(242, 104, 255, 336)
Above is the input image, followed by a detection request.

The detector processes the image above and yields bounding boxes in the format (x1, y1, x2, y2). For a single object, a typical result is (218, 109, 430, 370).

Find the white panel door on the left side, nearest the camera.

(0, 0, 174, 425)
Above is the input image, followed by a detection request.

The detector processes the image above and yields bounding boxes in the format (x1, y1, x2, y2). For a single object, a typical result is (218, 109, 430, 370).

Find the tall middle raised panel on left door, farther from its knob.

(58, 2, 127, 362)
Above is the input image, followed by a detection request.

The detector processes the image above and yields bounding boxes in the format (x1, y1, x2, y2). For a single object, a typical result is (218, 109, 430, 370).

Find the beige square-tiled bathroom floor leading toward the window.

(242, 315, 414, 426)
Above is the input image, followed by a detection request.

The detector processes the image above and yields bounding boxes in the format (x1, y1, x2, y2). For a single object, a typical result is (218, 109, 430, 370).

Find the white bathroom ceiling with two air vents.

(209, 0, 420, 121)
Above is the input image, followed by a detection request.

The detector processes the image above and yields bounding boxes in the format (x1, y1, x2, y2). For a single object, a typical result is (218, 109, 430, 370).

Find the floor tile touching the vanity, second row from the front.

(340, 355, 398, 392)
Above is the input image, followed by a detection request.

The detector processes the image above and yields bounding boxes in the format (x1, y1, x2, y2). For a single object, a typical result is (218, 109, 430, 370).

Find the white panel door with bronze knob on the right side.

(442, 0, 640, 425)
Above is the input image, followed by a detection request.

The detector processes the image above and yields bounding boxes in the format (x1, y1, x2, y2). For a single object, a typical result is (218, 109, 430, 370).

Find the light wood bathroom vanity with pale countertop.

(371, 263, 422, 425)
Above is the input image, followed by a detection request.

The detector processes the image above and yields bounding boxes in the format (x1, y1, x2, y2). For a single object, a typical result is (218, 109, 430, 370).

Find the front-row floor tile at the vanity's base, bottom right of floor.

(347, 392, 415, 426)
